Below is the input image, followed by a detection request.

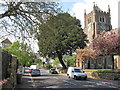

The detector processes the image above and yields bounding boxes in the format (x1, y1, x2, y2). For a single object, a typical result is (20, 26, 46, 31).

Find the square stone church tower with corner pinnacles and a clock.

(84, 3, 112, 43)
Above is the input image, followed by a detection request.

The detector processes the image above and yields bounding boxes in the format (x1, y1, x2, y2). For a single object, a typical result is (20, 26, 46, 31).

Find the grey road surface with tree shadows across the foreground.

(17, 70, 118, 90)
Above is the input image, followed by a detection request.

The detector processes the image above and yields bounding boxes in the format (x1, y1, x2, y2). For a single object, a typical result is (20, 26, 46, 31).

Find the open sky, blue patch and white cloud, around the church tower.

(59, 0, 120, 29)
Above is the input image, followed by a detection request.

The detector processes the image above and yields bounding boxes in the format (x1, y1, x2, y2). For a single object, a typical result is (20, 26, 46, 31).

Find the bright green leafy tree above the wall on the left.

(3, 41, 34, 66)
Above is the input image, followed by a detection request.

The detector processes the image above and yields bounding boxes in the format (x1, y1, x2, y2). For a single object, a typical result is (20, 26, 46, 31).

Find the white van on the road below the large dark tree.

(67, 67, 87, 80)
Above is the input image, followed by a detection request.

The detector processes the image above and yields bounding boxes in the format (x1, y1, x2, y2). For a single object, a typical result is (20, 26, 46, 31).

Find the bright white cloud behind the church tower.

(70, 0, 120, 28)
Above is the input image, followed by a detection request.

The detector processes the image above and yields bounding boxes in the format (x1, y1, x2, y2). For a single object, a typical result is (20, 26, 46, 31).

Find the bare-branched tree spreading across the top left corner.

(0, 0, 60, 39)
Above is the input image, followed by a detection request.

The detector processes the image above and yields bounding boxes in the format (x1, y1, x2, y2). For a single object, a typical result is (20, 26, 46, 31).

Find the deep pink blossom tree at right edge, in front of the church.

(93, 28, 120, 68)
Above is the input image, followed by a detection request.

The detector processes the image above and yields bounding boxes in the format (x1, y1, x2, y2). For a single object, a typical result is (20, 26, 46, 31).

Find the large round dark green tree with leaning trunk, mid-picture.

(36, 13, 87, 69)
